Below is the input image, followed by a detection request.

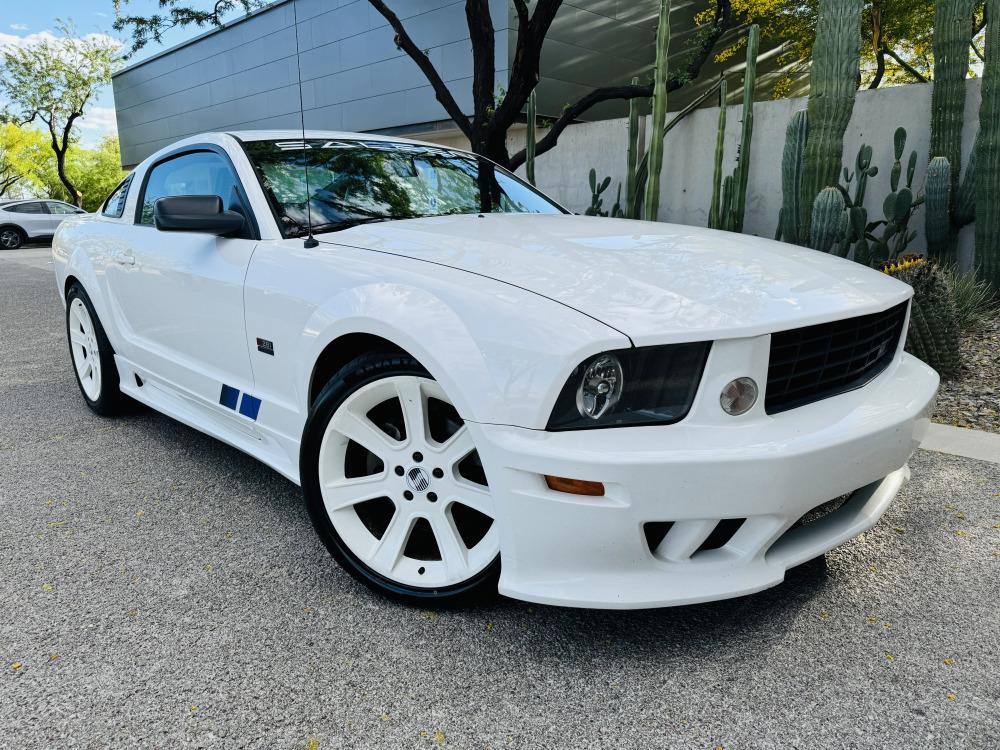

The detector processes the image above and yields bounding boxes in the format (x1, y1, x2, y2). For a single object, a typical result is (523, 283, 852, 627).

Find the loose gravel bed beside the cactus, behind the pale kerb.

(934, 314, 1000, 432)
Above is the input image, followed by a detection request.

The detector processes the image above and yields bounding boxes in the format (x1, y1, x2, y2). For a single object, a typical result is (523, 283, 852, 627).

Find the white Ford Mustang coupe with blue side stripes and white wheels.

(53, 131, 938, 608)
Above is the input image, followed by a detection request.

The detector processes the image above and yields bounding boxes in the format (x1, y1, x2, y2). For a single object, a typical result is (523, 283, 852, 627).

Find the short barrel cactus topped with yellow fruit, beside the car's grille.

(882, 256, 962, 378)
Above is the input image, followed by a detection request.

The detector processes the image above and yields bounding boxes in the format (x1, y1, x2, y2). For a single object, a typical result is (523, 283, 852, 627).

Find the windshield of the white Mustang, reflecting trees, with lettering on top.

(236, 140, 562, 237)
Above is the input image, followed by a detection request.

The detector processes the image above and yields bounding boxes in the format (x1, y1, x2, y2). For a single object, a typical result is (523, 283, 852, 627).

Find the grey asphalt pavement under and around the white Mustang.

(0, 251, 1000, 750)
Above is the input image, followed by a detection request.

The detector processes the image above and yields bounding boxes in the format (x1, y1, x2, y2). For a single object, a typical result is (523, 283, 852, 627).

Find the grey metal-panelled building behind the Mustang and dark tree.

(113, 0, 776, 166)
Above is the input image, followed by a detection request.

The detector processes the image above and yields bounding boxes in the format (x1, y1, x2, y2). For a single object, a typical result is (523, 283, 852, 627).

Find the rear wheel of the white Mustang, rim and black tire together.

(66, 284, 130, 417)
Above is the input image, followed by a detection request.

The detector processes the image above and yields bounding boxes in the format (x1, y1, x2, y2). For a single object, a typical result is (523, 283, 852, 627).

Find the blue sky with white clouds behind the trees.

(0, 0, 224, 147)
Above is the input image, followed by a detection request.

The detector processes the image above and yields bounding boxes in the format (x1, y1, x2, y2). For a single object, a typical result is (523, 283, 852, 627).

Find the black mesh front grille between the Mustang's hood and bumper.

(764, 302, 907, 414)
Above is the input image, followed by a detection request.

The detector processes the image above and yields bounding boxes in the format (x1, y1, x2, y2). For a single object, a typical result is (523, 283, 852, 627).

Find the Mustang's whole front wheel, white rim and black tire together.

(300, 353, 500, 606)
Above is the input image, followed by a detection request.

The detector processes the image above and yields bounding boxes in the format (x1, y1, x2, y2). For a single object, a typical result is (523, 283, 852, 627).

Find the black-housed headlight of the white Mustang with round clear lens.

(547, 342, 711, 430)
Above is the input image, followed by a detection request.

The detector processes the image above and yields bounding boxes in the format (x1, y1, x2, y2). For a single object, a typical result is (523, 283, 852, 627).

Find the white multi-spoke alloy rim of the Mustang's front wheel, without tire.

(319, 375, 500, 588)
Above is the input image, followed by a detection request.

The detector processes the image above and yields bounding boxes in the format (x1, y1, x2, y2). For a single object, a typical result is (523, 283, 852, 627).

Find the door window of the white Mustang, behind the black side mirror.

(138, 151, 236, 226)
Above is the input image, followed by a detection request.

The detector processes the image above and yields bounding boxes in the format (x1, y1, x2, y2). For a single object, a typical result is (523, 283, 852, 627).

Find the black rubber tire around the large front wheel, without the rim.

(299, 352, 500, 607)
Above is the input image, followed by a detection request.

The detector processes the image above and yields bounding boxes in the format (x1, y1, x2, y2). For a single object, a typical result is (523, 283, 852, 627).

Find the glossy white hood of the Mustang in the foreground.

(319, 214, 911, 346)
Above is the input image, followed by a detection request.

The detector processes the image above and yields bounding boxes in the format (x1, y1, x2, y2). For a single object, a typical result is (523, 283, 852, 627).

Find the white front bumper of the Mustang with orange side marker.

(469, 352, 938, 608)
